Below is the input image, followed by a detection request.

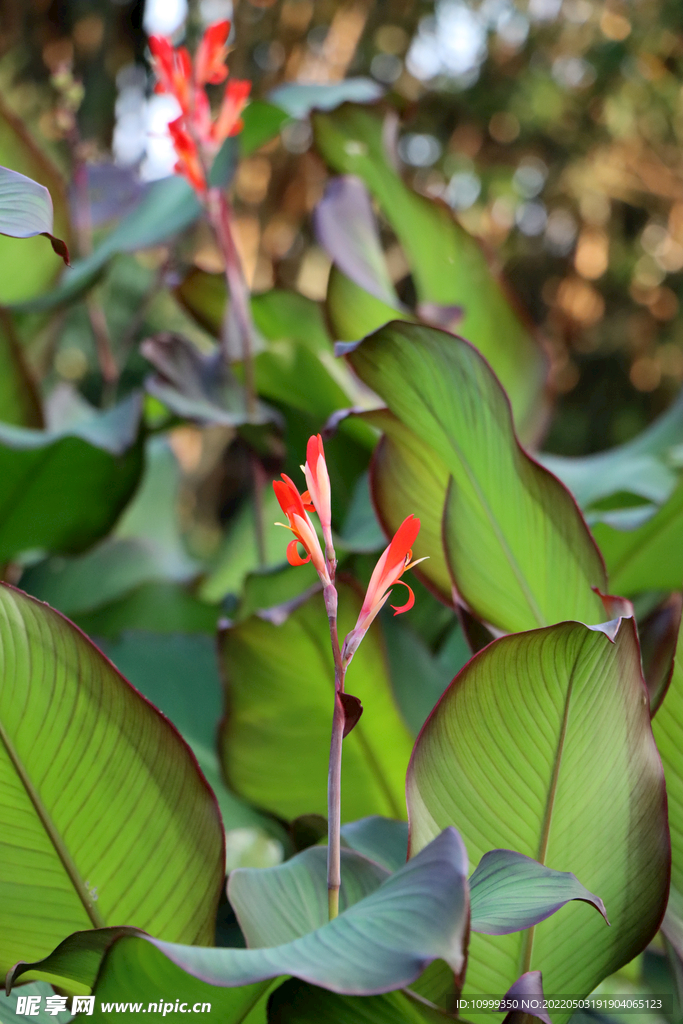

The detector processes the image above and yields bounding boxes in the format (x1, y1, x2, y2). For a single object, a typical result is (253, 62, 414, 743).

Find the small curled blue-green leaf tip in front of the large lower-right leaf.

(470, 850, 609, 935)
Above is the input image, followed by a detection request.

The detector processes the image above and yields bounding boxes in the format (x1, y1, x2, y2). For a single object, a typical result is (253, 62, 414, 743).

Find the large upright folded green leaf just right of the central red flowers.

(349, 322, 606, 632)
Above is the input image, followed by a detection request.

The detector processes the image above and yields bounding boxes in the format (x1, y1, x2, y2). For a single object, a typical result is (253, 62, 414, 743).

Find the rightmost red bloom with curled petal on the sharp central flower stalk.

(342, 515, 425, 665)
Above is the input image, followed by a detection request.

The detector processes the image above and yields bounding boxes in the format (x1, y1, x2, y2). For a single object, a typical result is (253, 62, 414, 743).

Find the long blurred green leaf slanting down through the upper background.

(313, 105, 545, 439)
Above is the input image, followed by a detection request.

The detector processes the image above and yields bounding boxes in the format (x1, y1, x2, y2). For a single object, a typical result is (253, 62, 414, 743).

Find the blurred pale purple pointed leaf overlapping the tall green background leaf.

(314, 174, 402, 310)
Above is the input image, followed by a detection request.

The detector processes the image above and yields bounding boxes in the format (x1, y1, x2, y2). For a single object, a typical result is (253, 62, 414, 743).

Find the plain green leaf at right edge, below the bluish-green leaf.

(593, 483, 683, 597)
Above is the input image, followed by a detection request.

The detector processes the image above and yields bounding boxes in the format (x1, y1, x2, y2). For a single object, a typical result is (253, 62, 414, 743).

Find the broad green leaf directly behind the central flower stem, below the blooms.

(220, 581, 412, 821)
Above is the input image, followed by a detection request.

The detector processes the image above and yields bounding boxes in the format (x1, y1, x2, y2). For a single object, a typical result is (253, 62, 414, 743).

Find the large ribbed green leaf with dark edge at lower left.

(0, 588, 223, 971)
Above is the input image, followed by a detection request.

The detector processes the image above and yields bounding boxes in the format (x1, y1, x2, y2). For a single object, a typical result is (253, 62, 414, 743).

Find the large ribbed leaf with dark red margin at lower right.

(408, 620, 670, 1021)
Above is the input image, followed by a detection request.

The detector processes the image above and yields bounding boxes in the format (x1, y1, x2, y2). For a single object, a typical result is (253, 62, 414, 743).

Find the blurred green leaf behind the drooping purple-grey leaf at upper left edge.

(0, 103, 71, 306)
